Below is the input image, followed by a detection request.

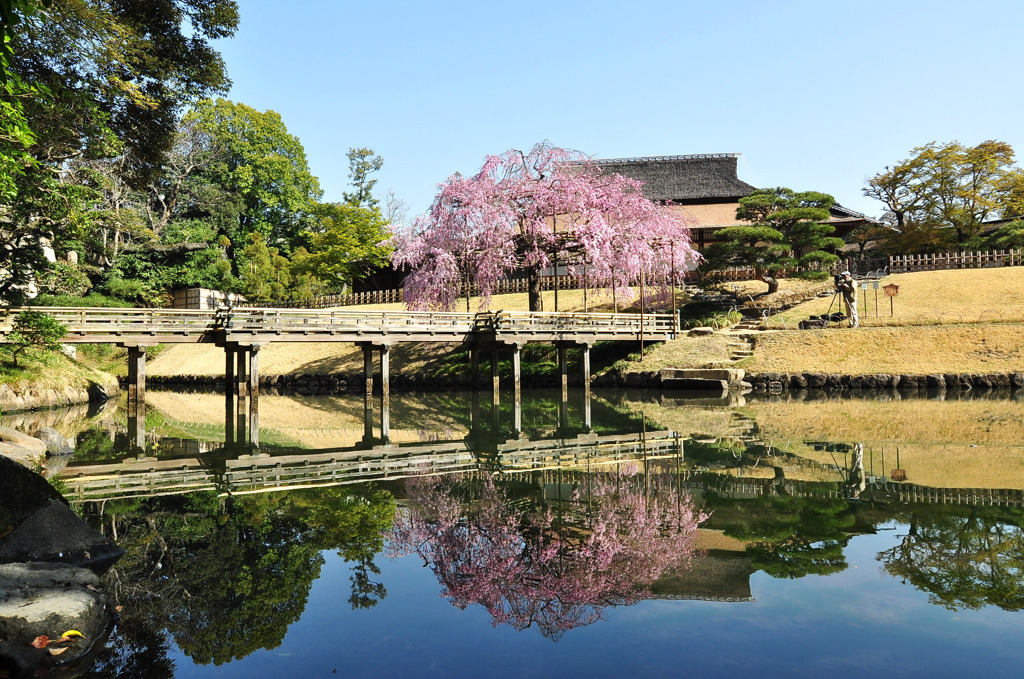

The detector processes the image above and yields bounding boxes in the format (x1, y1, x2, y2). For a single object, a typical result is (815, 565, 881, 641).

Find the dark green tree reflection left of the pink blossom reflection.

(79, 489, 394, 677)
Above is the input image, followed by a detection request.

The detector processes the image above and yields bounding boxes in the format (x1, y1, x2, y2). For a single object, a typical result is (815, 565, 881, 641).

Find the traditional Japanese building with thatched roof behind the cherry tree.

(595, 154, 872, 250)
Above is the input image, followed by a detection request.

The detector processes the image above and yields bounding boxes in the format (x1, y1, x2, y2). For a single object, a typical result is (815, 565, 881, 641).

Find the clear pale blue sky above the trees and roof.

(211, 0, 1024, 222)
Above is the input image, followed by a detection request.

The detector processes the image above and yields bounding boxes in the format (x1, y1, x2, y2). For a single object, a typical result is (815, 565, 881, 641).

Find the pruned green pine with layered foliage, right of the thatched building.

(705, 187, 843, 293)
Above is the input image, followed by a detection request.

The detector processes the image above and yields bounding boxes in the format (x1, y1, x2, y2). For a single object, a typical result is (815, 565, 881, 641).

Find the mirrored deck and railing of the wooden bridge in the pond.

(62, 431, 682, 501)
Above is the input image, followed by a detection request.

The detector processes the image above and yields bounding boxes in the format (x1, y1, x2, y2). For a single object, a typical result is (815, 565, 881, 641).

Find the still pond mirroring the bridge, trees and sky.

(28, 391, 1024, 678)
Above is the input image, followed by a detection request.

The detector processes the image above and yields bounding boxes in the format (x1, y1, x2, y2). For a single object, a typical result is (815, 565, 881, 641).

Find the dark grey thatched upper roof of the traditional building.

(594, 154, 756, 203)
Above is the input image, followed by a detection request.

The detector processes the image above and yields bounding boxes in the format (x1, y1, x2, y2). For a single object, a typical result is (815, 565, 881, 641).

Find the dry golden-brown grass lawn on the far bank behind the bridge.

(147, 267, 1024, 375)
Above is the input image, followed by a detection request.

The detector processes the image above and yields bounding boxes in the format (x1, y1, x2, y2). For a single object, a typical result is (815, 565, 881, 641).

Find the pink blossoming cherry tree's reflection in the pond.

(391, 467, 707, 639)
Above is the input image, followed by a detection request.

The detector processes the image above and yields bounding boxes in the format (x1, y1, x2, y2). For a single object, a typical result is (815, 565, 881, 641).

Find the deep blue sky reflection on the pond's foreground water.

(167, 526, 1024, 677)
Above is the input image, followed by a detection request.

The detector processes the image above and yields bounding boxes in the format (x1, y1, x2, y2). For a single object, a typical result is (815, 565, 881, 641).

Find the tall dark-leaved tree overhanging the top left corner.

(0, 0, 238, 302)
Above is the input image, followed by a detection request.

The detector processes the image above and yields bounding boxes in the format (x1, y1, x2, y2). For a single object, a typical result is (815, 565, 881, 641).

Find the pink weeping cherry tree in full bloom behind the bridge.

(393, 143, 694, 311)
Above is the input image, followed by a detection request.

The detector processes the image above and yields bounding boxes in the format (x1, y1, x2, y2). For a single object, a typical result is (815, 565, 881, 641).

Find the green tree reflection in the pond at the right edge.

(878, 507, 1024, 610)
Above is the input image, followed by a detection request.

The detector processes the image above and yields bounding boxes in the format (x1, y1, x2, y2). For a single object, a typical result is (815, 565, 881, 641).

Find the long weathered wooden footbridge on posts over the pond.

(0, 307, 678, 428)
